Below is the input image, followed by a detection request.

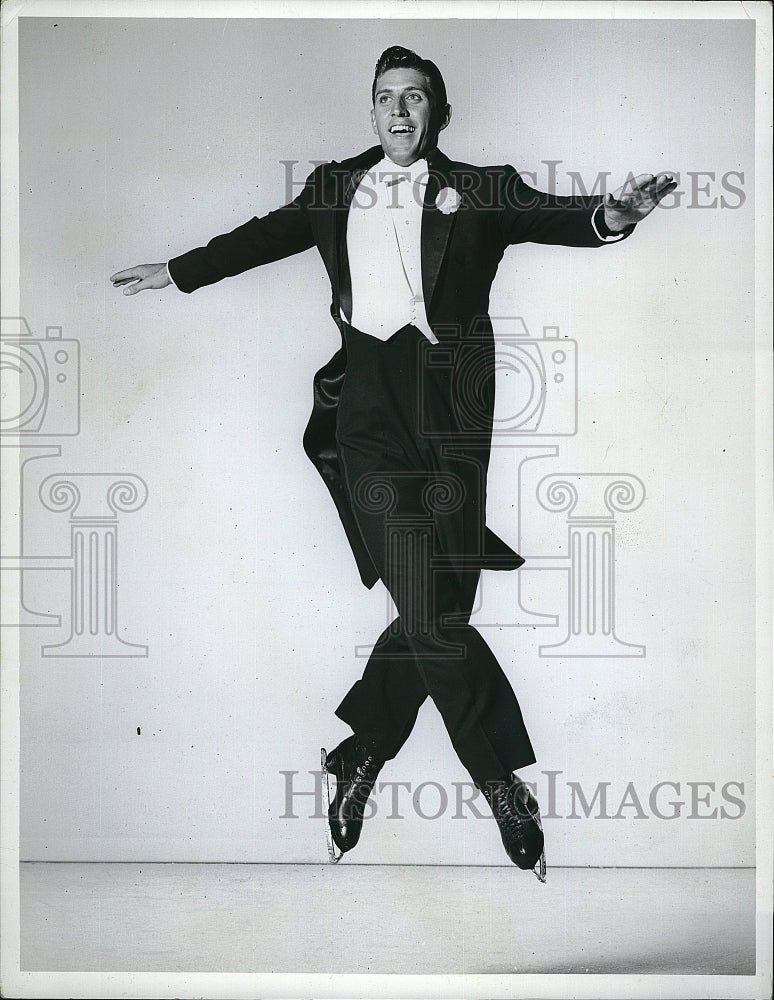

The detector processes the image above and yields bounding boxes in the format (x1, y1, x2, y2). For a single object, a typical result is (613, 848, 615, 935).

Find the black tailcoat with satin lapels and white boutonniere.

(169, 146, 624, 587)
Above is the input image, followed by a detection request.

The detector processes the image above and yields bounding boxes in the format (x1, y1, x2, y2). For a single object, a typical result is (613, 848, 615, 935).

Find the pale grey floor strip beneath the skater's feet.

(20, 861, 755, 975)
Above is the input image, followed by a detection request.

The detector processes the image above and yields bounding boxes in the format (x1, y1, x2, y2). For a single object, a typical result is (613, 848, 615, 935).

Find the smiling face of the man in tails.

(371, 68, 449, 167)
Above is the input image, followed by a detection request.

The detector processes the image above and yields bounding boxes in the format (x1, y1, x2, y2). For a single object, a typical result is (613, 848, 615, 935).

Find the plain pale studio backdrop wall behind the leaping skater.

(12, 11, 755, 866)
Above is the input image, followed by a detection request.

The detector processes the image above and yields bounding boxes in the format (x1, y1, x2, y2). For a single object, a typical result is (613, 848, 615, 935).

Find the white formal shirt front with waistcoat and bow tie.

(344, 156, 438, 344)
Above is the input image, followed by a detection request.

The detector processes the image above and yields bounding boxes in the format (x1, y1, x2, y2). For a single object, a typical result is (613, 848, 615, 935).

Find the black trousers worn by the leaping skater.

(336, 326, 535, 784)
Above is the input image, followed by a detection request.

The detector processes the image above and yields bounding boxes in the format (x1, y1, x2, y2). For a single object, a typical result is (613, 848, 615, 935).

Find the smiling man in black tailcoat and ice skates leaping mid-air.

(111, 46, 675, 881)
